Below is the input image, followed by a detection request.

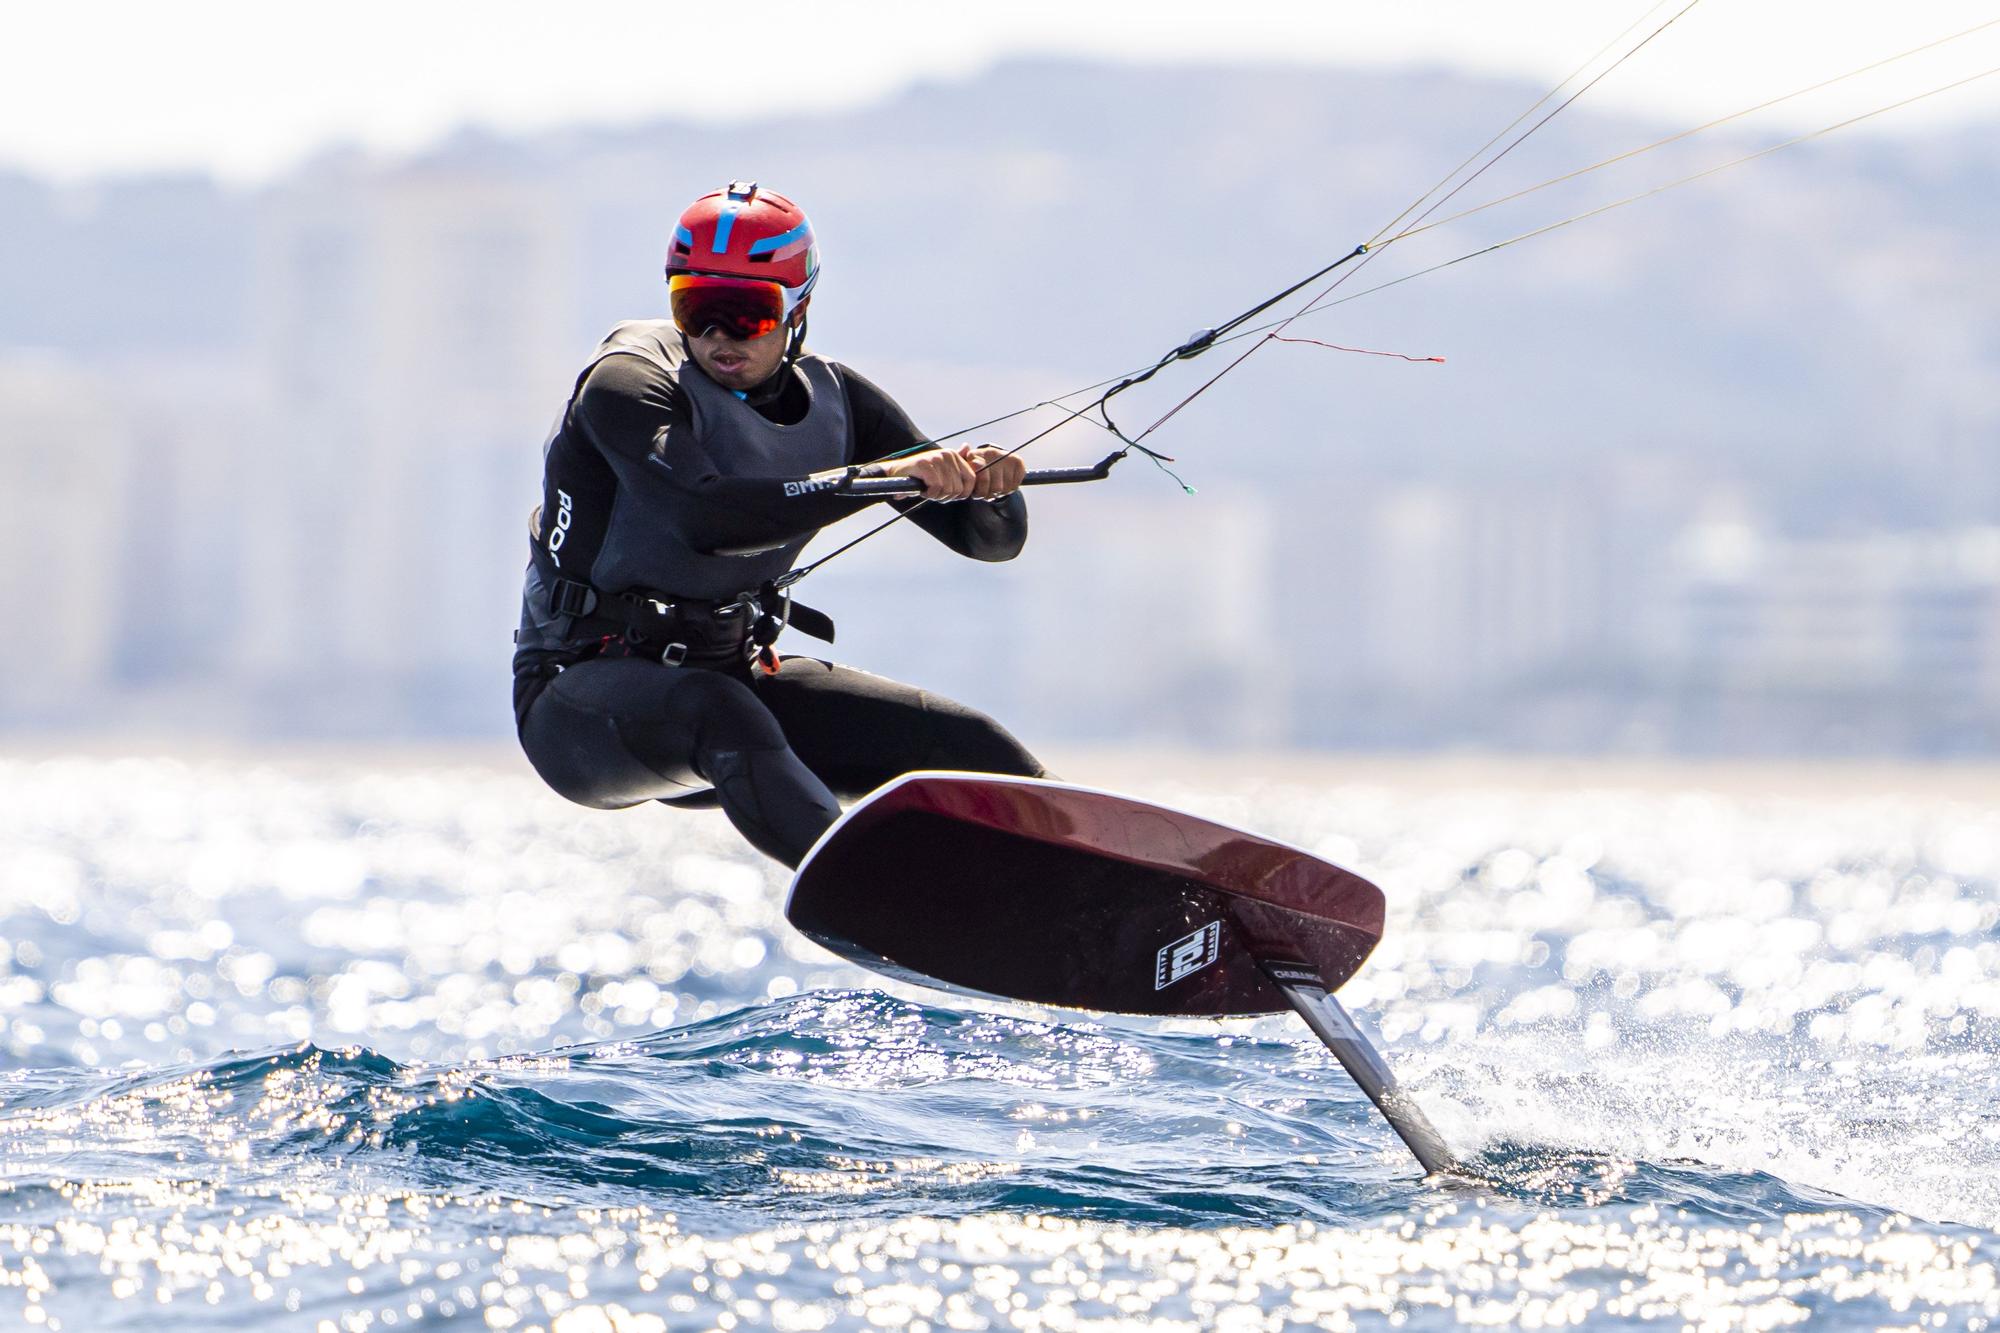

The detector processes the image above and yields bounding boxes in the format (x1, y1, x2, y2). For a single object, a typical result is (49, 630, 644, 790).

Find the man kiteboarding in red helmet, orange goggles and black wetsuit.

(514, 182, 1046, 865)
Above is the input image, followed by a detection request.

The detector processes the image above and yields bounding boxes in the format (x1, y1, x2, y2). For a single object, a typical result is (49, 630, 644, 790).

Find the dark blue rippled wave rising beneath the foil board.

(0, 991, 1928, 1225)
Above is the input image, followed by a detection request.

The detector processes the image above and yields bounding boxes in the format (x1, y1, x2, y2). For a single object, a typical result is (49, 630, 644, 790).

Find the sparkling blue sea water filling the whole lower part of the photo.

(0, 759, 2000, 1333)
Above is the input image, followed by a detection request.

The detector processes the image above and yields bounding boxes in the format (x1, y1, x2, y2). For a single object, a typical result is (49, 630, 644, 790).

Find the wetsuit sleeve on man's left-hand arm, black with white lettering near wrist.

(574, 356, 892, 550)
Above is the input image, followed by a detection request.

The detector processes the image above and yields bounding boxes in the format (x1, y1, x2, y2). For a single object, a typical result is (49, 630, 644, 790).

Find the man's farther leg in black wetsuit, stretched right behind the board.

(754, 656, 1048, 799)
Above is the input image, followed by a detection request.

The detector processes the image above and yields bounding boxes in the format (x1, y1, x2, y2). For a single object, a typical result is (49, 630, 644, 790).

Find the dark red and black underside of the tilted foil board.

(786, 773, 1382, 1017)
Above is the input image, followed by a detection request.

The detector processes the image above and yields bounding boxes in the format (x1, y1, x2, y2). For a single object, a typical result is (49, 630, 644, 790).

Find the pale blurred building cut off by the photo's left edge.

(0, 354, 274, 731)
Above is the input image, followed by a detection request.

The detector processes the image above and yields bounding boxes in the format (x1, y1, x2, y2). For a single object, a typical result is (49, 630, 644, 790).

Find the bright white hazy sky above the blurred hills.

(0, 0, 2000, 180)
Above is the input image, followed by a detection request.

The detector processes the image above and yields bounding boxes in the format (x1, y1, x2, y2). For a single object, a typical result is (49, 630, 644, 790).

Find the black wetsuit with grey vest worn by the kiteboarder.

(514, 322, 1044, 865)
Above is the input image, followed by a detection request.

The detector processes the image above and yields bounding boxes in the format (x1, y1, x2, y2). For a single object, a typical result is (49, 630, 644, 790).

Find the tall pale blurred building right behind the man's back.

(246, 164, 588, 731)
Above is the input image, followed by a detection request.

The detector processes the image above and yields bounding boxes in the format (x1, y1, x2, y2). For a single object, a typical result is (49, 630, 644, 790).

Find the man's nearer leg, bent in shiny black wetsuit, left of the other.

(520, 656, 840, 865)
